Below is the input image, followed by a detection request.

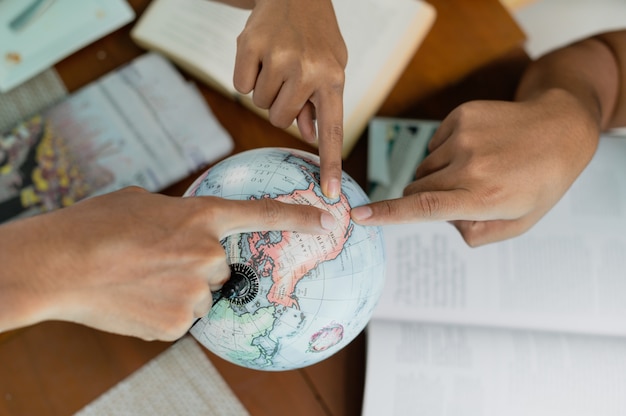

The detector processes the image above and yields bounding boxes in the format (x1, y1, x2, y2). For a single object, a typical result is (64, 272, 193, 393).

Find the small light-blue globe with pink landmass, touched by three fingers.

(185, 148, 385, 371)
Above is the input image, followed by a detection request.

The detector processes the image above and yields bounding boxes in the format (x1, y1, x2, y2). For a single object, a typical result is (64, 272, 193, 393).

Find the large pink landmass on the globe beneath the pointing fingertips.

(247, 184, 353, 308)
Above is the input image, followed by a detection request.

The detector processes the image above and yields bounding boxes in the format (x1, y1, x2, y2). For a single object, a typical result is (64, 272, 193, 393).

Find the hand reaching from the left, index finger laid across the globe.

(0, 188, 335, 340)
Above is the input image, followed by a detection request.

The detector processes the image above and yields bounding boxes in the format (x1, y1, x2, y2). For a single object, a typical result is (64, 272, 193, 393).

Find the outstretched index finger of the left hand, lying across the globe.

(200, 197, 337, 239)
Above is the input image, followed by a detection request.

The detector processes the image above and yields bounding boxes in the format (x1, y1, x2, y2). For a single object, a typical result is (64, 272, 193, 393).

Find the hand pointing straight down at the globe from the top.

(234, 0, 348, 198)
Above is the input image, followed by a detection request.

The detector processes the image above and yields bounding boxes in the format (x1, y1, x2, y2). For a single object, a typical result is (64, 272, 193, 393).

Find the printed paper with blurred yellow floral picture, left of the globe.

(0, 53, 233, 222)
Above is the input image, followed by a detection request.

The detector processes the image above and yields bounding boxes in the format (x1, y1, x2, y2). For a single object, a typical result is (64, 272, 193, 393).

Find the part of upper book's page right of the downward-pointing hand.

(333, 0, 436, 157)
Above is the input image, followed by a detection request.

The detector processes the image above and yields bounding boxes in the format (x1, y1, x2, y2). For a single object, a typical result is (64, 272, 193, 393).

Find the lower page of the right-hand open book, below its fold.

(362, 320, 626, 416)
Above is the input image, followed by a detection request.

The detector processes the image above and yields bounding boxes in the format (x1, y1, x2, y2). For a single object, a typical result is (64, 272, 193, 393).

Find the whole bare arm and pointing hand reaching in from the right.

(352, 30, 626, 246)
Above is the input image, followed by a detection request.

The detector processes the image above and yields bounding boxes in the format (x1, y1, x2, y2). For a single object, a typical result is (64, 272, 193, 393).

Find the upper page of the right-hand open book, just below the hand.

(374, 137, 626, 335)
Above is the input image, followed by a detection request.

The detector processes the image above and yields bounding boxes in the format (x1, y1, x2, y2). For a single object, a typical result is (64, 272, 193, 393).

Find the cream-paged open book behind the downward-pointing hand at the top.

(131, 0, 435, 157)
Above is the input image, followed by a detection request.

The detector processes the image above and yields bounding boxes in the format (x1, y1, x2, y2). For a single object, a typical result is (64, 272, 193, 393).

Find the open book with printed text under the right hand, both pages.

(363, 132, 626, 416)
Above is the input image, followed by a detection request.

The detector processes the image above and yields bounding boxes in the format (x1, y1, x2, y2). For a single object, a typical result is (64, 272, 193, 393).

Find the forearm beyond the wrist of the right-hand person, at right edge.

(516, 30, 626, 130)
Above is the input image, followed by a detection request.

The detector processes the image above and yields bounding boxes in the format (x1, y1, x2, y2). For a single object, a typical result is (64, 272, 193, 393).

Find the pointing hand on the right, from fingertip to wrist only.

(352, 90, 599, 246)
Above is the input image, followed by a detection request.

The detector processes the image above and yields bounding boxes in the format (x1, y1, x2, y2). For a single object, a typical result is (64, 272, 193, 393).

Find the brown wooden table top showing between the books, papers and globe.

(0, 0, 528, 416)
